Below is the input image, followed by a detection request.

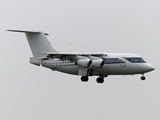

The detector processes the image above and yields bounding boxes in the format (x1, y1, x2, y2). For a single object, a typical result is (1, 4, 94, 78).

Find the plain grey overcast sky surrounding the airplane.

(0, 0, 160, 120)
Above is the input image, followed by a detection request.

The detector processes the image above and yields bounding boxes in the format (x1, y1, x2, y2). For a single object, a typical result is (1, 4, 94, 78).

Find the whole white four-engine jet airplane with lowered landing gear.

(7, 30, 155, 83)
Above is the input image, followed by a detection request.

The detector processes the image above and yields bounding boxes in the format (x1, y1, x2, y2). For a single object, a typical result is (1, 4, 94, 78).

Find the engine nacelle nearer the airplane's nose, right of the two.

(92, 59, 105, 68)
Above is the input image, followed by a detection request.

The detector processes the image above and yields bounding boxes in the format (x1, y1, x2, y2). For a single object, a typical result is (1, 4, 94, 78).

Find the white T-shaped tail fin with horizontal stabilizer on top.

(8, 30, 56, 57)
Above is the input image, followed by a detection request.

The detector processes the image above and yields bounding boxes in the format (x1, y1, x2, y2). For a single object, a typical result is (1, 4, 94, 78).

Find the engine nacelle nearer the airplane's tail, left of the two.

(76, 59, 92, 67)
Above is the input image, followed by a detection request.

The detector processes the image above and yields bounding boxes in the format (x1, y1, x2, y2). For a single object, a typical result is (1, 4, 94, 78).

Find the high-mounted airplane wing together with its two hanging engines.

(42, 52, 107, 68)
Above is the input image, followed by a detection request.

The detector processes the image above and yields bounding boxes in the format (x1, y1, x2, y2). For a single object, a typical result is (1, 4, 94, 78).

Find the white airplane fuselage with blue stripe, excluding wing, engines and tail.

(42, 53, 154, 77)
